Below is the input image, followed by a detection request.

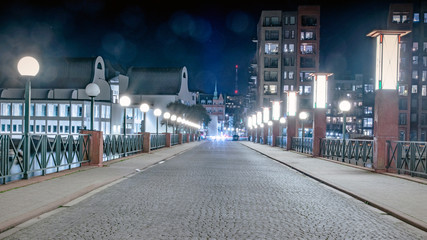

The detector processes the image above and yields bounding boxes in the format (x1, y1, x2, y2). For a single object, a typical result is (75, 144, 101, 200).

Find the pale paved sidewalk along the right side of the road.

(240, 141, 427, 231)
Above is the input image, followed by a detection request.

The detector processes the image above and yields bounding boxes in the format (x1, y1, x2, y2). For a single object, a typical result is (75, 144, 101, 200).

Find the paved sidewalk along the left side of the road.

(0, 142, 202, 233)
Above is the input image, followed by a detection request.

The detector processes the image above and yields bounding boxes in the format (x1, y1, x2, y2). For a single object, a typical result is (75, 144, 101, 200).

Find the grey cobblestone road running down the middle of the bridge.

(3, 142, 427, 240)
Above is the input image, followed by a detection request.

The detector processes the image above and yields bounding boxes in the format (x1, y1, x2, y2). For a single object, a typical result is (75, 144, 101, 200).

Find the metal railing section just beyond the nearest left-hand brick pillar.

(103, 134, 144, 161)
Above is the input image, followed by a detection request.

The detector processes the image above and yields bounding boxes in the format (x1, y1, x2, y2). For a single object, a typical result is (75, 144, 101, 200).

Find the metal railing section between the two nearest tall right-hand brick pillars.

(320, 138, 374, 168)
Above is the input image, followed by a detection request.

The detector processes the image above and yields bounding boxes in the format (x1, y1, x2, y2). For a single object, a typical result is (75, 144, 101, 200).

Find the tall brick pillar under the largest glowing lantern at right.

(373, 89, 399, 172)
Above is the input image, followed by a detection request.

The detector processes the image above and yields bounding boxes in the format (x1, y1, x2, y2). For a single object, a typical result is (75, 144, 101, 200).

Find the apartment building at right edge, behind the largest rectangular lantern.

(387, 1, 427, 141)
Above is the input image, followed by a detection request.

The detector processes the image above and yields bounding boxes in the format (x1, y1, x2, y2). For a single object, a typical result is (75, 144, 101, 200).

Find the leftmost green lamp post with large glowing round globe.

(17, 56, 40, 179)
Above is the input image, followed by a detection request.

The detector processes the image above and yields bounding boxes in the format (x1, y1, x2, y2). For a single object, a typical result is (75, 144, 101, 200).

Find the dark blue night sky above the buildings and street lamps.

(0, 0, 418, 93)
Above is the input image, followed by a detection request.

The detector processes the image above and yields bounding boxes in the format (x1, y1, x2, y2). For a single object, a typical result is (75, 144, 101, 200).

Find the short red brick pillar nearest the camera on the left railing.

(80, 130, 104, 167)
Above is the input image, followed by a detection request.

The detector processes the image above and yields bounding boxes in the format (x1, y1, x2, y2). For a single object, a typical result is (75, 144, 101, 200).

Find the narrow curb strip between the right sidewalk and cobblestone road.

(241, 143, 427, 232)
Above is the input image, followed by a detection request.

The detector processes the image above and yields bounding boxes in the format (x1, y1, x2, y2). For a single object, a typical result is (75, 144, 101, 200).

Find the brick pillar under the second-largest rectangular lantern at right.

(313, 108, 326, 157)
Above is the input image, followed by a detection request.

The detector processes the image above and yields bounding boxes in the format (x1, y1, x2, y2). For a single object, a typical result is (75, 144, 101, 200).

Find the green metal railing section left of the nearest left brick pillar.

(0, 134, 90, 184)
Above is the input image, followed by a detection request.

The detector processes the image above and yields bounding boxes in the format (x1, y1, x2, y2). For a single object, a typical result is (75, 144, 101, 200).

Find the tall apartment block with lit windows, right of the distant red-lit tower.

(255, 6, 320, 116)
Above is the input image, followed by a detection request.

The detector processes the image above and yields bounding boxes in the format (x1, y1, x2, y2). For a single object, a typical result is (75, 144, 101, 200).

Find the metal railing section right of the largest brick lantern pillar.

(386, 140, 427, 178)
